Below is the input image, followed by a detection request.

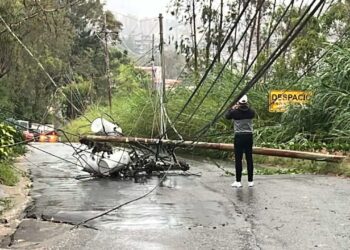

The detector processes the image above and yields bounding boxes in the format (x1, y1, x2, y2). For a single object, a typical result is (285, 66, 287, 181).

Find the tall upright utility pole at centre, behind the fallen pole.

(159, 14, 167, 138)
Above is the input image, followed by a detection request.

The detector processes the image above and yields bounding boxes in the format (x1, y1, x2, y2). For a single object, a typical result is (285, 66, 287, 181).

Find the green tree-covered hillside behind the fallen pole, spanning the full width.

(0, 0, 350, 154)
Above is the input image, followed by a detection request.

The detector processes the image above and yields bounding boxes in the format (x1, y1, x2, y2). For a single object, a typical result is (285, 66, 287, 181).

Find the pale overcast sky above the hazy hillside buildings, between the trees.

(105, 0, 170, 18)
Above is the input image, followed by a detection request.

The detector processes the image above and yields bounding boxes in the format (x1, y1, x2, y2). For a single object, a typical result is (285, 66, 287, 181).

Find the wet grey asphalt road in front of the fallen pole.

(2, 144, 350, 249)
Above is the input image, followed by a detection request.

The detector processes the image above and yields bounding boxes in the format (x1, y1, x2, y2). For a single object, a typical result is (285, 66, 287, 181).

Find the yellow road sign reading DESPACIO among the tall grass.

(269, 90, 312, 112)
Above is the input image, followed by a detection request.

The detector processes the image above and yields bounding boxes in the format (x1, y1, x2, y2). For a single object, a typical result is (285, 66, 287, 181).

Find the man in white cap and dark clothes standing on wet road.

(225, 95, 255, 188)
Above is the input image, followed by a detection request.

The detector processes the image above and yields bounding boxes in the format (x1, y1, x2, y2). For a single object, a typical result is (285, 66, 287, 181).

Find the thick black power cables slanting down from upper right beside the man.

(160, 0, 325, 143)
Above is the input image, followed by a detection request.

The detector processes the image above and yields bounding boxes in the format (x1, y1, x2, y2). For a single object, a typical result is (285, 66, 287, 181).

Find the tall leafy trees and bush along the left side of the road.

(0, 0, 128, 185)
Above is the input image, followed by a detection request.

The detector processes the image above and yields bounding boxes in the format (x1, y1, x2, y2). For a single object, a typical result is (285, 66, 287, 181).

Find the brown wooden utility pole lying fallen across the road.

(84, 135, 345, 162)
